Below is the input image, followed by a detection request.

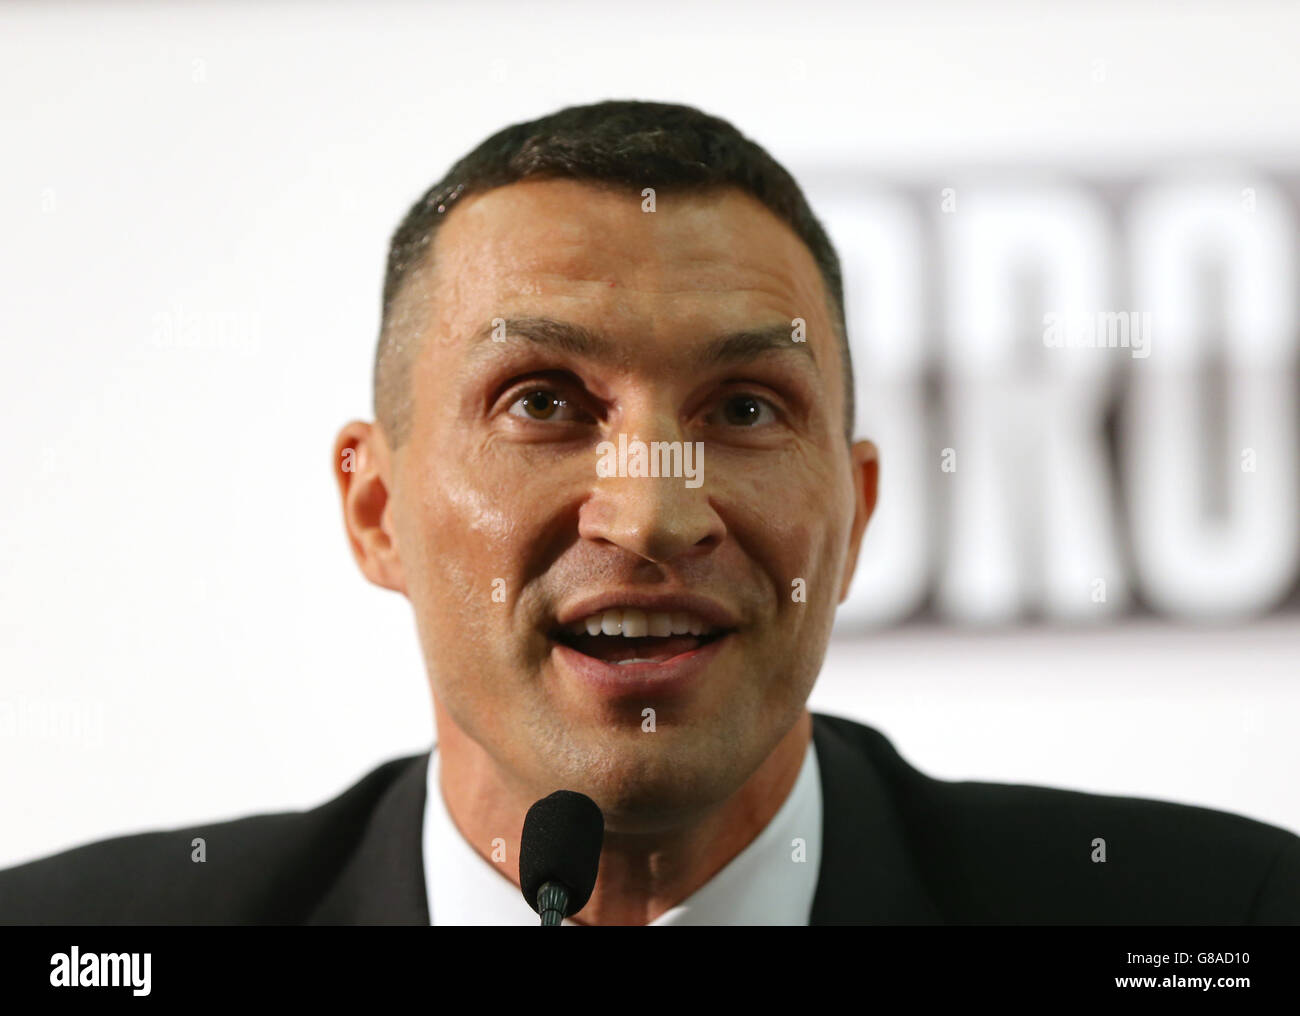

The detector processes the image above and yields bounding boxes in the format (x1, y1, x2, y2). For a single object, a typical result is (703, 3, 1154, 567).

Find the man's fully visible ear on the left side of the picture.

(334, 420, 407, 595)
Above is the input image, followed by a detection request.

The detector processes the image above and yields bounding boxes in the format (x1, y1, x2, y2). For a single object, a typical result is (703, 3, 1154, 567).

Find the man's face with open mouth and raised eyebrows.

(377, 181, 870, 830)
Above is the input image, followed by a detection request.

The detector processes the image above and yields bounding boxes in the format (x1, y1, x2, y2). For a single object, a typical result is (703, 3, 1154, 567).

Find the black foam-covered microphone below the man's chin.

(519, 790, 605, 928)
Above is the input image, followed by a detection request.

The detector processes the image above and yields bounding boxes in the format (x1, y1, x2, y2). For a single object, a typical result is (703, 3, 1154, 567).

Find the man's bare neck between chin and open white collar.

(434, 699, 813, 925)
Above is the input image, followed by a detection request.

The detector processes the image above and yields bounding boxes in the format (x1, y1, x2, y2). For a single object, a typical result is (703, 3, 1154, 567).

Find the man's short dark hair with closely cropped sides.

(374, 100, 854, 448)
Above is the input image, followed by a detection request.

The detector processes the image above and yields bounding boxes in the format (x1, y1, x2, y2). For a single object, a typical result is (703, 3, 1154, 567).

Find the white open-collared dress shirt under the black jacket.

(424, 739, 822, 926)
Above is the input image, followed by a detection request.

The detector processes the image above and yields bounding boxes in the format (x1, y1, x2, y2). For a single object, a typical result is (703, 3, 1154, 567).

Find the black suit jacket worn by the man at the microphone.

(0, 713, 1300, 925)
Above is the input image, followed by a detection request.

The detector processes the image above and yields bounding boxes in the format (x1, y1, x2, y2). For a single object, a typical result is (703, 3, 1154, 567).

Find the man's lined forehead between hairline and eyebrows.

(426, 179, 829, 337)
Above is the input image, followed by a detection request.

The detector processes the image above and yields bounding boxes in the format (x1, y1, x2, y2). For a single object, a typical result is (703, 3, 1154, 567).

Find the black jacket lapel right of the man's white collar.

(809, 713, 943, 925)
